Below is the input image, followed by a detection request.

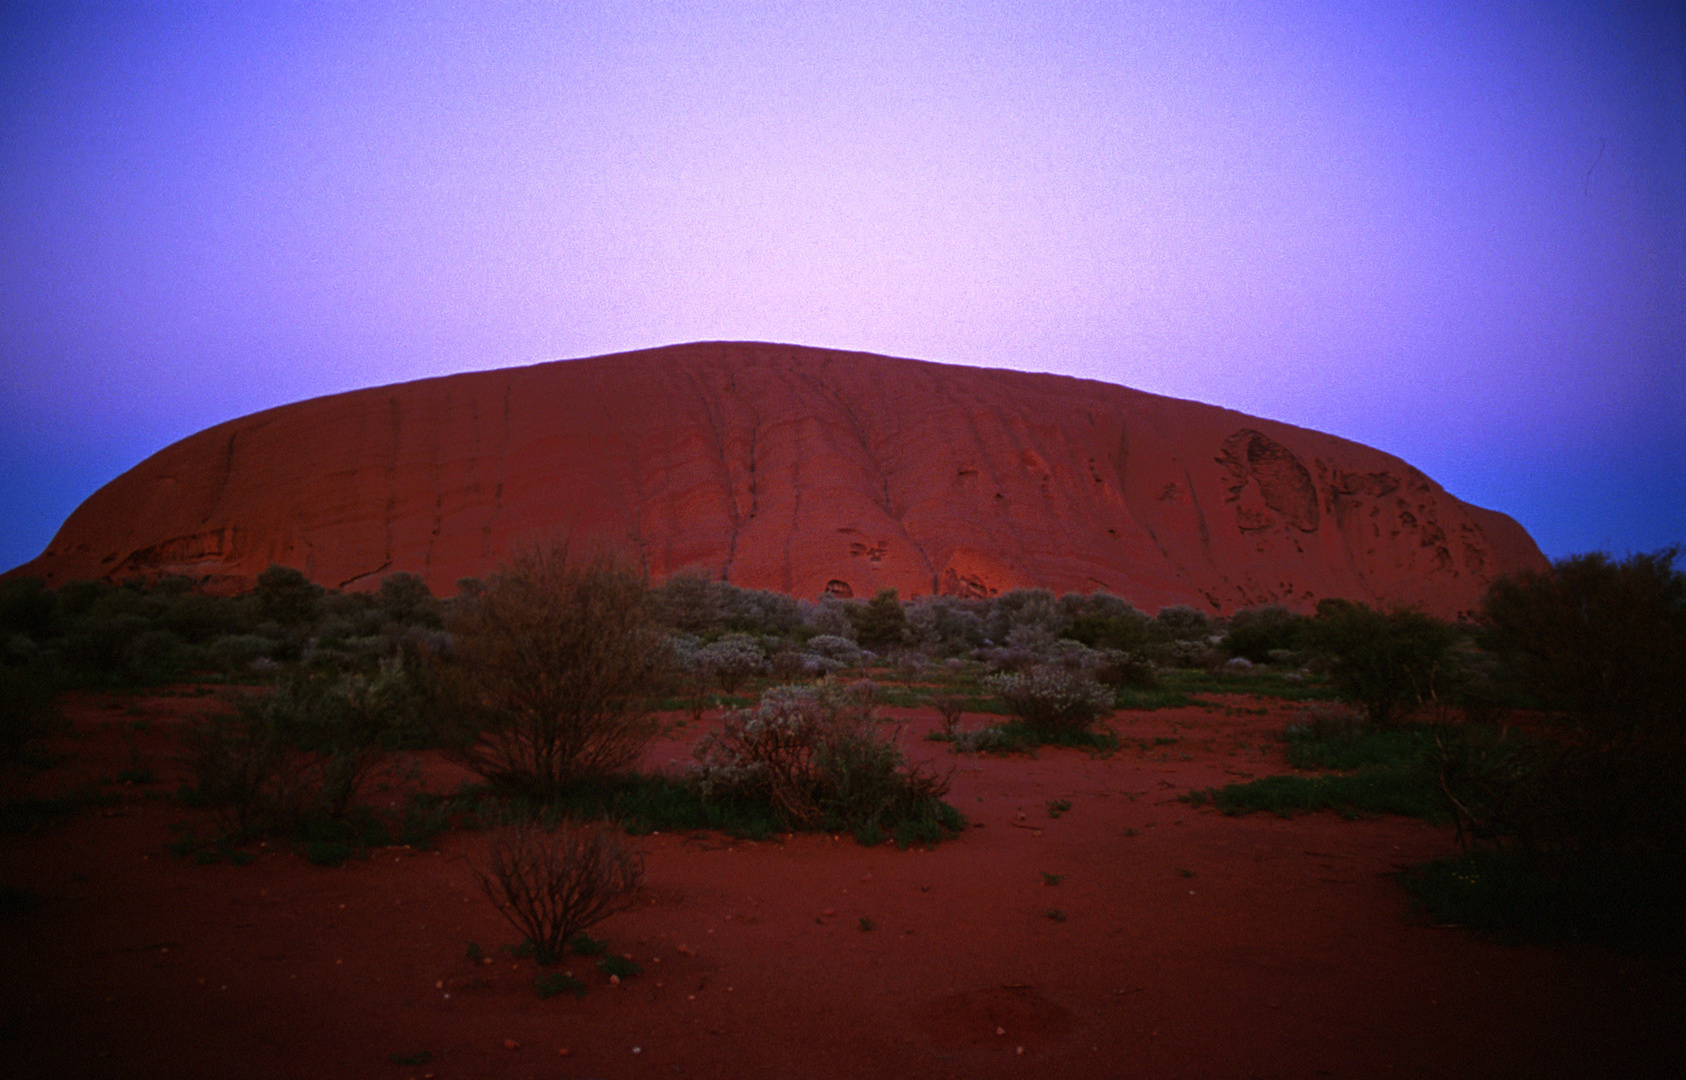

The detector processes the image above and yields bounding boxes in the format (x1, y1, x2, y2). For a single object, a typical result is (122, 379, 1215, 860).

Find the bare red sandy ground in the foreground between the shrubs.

(0, 694, 1686, 1080)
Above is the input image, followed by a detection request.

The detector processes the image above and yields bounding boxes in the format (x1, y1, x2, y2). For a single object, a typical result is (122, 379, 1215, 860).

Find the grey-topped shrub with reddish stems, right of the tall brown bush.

(693, 682, 948, 832)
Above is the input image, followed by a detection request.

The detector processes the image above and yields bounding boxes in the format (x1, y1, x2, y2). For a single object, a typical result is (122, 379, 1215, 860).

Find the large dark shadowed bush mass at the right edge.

(1428, 548, 1686, 947)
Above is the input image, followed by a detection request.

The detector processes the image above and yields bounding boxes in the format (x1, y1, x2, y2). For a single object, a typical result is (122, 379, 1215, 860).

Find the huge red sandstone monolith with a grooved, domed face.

(13, 342, 1546, 615)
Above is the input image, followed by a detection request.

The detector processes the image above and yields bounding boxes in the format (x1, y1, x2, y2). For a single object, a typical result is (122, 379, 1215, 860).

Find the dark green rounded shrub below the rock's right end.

(1307, 600, 1457, 726)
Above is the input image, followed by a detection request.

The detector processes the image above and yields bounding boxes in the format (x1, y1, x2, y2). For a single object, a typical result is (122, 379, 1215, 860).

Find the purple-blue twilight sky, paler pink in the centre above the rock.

(0, 0, 1686, 568)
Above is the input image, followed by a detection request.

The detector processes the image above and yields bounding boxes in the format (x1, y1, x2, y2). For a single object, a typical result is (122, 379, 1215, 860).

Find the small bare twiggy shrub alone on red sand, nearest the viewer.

(474, 821, 644, 964)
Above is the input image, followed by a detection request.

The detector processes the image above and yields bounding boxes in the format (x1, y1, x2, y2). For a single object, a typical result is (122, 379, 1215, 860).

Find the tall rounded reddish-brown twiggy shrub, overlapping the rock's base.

(433, 546, 669, 799)
